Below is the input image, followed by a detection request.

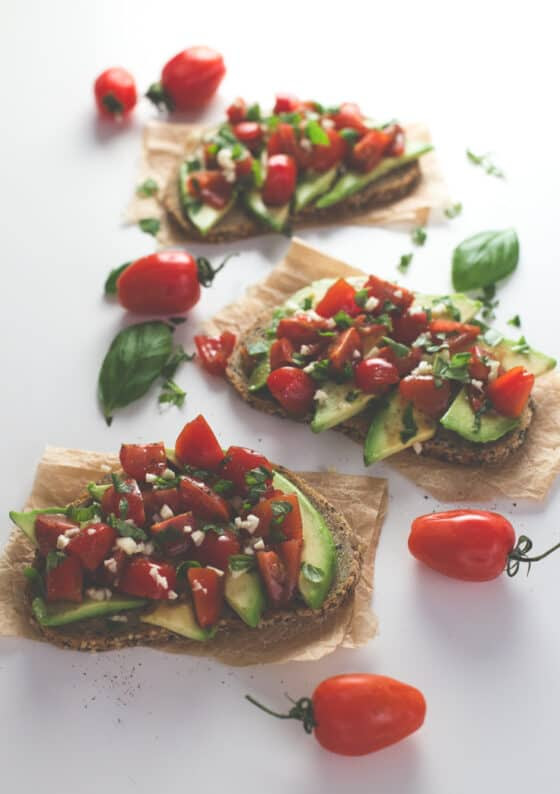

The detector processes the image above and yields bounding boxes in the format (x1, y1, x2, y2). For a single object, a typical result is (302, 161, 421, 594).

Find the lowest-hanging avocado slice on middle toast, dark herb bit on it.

(364, 389, 437, 466)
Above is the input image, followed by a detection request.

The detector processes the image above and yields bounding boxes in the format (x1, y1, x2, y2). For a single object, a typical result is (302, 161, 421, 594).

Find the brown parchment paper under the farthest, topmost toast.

(125, 121, 450, 245)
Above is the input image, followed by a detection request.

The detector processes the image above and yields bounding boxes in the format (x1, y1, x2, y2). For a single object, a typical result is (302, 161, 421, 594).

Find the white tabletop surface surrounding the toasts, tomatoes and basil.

(0, 0, 560, 794)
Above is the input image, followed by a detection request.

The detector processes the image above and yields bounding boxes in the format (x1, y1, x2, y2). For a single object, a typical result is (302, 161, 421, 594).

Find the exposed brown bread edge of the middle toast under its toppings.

(226, 311, 535, 466)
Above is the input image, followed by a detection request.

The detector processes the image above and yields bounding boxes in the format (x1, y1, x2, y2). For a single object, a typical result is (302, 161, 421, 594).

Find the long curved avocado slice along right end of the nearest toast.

(273, 471, 336, 609)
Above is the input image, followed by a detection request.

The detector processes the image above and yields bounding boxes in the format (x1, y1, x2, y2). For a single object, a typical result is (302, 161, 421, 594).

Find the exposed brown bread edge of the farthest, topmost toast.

(162, 160, 422, 243)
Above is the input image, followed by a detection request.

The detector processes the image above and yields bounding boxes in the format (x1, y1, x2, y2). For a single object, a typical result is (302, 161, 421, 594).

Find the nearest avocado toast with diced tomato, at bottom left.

(10, 416, 361, 650)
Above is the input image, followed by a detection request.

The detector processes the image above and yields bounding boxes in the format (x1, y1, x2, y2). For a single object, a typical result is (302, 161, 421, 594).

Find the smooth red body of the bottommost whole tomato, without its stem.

(312, 673, 426, 756)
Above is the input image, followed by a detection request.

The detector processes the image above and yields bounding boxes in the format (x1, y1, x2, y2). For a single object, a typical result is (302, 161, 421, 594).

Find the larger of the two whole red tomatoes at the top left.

(146, 47, 226, 111)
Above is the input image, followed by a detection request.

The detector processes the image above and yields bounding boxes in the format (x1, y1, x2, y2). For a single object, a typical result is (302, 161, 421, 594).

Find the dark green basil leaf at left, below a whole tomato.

(98, 320, 173, 424)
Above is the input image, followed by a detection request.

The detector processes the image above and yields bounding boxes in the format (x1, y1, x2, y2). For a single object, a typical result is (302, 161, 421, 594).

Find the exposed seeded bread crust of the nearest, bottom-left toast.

(25, 466, 365, 664)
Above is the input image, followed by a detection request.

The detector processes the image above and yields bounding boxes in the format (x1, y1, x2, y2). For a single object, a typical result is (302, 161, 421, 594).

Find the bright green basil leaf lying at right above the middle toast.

(452, 229, 519, 292)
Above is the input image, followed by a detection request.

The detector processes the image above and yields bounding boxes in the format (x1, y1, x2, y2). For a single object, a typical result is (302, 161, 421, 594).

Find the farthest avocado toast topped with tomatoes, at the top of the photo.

(164, 96, 432, 241)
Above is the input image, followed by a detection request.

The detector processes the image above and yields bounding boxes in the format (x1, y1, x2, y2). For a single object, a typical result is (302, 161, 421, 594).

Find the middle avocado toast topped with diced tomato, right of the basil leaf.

(227, 275, 556, 465)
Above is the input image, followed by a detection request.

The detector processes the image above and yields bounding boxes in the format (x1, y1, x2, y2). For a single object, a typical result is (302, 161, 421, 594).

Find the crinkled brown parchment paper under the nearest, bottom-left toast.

(0, 447, 387, 665)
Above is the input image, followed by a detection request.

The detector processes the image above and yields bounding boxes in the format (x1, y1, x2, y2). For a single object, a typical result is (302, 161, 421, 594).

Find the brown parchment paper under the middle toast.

(206, 238, 560, 502)
